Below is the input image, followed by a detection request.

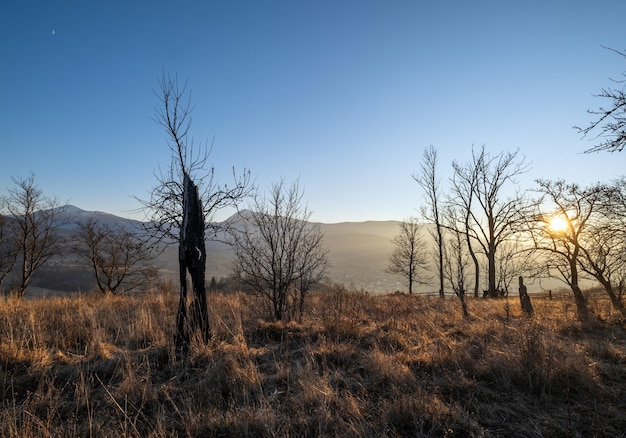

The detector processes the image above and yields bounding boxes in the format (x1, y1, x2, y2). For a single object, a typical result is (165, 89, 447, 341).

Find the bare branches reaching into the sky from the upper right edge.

(574, 48, 626, 153)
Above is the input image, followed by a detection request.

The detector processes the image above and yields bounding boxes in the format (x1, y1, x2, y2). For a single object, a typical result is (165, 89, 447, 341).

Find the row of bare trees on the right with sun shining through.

(388, 146, 626, 320)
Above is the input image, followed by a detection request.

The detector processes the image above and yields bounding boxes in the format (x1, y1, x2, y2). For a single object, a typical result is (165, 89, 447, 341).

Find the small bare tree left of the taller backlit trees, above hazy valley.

(386, 217, 429, 294)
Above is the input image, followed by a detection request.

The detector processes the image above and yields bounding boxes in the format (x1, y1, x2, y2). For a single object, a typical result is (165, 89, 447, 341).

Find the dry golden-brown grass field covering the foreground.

(0, 289, 626, 437)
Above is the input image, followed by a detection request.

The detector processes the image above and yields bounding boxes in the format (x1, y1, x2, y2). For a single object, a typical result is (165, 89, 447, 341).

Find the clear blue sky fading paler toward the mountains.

(0, 0, 626, 222)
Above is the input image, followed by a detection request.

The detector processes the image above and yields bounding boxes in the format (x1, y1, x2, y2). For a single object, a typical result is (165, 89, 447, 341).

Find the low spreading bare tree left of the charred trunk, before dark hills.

(76, 219, 157, 294)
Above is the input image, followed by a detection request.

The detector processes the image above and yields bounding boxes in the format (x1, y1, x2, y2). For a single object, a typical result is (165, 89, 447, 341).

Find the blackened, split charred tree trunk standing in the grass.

(175, 172, 211, 352)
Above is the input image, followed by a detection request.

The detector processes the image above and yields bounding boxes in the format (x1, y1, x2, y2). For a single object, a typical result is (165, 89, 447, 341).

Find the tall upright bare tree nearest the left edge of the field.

(4, 174, 66, 297)
